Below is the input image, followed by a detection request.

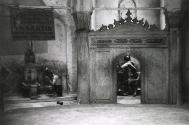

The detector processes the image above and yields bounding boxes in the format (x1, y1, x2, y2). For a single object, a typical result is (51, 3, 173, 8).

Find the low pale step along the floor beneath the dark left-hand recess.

(4, 94, 77, 111)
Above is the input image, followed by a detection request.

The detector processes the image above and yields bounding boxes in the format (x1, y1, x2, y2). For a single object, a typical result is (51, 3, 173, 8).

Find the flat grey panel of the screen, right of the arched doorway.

(145, 49, 168, 103)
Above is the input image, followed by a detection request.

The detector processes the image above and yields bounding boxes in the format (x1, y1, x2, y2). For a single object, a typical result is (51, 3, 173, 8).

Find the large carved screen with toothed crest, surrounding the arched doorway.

(88, 10, 169, 104)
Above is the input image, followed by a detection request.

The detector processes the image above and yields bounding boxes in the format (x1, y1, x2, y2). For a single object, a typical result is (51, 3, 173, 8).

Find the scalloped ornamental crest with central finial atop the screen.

(98, 10, 160, 32)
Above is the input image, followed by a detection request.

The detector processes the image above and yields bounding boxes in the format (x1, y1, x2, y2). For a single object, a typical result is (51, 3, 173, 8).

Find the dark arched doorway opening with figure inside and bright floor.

(116, 55, 141, 104)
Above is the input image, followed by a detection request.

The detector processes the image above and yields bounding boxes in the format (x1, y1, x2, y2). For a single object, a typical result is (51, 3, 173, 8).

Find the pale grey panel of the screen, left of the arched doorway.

(91, 51, 113, 103)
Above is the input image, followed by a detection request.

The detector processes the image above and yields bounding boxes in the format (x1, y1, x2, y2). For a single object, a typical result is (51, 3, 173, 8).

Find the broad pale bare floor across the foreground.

(4, 104, 189, 125)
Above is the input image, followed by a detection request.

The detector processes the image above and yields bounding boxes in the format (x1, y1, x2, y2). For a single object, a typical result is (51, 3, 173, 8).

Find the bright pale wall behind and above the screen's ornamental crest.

(92, 0, 160, 30)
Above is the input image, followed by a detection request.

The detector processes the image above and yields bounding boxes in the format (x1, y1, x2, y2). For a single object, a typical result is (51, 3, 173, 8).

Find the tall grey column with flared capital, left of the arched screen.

(73, 11, 91, 104)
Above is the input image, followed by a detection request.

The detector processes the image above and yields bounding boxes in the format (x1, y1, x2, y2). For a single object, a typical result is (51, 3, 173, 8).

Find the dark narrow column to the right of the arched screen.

(167, 11, 182, 105)
